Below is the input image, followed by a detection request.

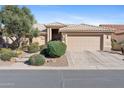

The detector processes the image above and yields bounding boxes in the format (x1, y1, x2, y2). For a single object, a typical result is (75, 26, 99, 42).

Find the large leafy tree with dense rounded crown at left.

(0, 5, 36, 48)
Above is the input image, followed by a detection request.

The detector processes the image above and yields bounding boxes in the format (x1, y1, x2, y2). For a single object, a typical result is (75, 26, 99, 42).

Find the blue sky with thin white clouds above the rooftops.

(0, 5, 124, 25)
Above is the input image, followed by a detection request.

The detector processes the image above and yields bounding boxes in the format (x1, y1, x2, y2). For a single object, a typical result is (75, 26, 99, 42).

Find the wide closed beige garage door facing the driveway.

(67, 36, 101, 51)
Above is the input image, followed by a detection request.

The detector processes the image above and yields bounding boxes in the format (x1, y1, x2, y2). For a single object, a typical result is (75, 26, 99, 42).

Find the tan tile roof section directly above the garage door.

(60, 24, 114, 32)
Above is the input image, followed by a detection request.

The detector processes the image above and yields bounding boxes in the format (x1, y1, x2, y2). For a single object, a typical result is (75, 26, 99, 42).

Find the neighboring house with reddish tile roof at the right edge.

(100, 24, 124, 42)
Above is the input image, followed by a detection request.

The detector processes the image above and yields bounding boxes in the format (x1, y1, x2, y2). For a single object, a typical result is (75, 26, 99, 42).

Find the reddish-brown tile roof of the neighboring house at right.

(99, 24, 124, 34)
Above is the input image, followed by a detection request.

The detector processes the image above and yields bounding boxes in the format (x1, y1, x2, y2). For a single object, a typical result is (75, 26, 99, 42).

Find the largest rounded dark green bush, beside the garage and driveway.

(46, 41, 66, 57)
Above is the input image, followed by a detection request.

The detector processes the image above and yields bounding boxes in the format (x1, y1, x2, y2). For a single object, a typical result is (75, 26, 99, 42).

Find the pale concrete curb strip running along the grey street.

(0, 66, 124, 70)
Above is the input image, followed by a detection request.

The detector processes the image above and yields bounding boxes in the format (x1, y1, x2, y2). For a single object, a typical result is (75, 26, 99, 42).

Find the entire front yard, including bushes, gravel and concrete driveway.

(0, 38, 124, 70)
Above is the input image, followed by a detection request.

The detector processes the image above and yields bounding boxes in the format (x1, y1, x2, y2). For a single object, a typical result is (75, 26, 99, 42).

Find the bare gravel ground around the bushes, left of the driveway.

(0, 52, 68, 67)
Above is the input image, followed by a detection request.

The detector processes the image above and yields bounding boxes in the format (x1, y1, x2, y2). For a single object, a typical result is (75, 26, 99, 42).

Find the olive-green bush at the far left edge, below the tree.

(0, 48, 17, 61)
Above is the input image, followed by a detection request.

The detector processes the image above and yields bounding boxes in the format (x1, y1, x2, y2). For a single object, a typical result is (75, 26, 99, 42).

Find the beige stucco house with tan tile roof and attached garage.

(36, 22, 114, 51)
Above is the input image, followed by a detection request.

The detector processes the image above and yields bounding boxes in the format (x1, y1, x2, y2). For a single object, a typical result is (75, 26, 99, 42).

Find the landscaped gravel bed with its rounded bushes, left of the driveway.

(0, 41, 68, 67)
